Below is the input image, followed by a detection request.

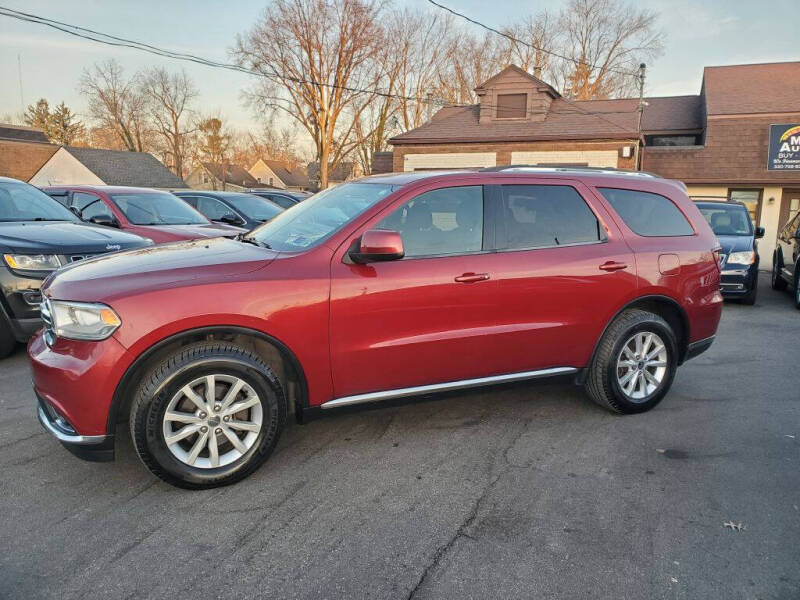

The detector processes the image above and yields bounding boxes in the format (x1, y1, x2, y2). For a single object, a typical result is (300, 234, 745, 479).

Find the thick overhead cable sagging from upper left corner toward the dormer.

(0, 6, 446, 104)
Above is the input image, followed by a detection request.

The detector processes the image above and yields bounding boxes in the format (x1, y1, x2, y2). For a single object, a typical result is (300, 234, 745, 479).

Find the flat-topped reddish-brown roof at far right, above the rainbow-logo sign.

(703, 62, 800, 115)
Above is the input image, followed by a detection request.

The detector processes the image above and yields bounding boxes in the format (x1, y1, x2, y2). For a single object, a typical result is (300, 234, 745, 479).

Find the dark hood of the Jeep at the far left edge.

(0, 221, 149, 254)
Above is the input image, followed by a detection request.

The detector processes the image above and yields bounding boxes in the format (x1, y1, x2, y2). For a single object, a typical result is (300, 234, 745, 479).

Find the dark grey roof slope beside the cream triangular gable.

(59, 146, 186, 188)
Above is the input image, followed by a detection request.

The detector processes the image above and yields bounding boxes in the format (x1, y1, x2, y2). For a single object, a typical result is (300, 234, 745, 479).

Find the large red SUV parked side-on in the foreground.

(29, 168, 722, 488)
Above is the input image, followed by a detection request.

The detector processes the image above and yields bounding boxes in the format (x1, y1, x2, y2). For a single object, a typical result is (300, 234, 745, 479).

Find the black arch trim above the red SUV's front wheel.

(111, 325, 308, 434)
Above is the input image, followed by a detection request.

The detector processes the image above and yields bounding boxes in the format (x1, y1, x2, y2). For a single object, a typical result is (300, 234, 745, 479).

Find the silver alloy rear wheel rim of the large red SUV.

(617, 331, 667, 402)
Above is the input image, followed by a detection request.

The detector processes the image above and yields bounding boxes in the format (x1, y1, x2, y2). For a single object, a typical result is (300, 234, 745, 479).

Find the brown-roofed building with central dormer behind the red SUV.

(382, 65, 702, 171)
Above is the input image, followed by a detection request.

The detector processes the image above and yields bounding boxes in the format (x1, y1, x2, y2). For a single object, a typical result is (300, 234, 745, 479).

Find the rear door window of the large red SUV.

(498, 185, 605, 250)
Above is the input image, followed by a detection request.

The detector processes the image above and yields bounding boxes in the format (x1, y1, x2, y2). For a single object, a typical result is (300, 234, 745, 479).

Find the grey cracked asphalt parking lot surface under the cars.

(0, 276, 800, 599)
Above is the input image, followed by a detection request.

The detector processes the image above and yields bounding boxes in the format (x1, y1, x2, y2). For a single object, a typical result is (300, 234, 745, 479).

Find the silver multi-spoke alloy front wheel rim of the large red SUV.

(162, 374, 264, 469)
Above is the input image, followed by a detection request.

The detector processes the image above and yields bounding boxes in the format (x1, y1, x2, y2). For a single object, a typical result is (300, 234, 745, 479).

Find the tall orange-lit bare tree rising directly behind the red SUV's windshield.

(234, 0, 383, 188)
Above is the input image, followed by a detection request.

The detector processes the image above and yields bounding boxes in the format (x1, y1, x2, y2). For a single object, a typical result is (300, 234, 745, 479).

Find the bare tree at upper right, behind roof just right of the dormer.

(557, 0, 663, 100)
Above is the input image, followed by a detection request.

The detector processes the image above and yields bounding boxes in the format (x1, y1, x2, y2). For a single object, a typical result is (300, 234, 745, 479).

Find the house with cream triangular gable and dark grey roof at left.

(29, 146, 186, 190)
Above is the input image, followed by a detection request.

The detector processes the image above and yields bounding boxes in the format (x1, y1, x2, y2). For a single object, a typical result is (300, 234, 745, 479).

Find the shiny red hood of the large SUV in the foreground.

(47, 238, 277, 302)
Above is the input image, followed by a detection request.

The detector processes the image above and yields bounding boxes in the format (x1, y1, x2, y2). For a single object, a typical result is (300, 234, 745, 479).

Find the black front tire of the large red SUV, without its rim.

(137, 357, 282, 487)
